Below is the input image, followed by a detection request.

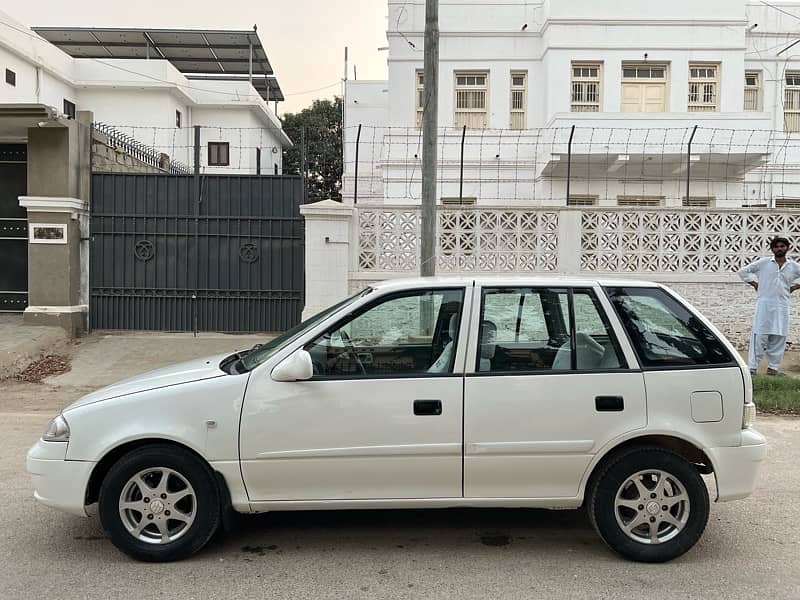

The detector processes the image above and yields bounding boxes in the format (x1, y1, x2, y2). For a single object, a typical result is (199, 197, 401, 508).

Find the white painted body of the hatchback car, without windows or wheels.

(28, 278, 766, 514)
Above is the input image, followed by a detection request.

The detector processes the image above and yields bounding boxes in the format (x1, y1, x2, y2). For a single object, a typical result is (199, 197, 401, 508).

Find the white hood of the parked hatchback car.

(64, 353, 230, 412)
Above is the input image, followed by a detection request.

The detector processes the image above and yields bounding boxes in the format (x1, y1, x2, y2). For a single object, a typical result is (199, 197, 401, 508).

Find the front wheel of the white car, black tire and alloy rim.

(99, 444, 220, 562)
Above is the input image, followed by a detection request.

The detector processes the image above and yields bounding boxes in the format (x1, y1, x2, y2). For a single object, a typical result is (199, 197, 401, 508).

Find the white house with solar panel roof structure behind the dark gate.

(0, 12, 291, 174)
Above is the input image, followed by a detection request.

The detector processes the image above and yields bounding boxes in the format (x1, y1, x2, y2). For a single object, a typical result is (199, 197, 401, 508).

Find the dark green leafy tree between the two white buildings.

(283, 96, 342, 202)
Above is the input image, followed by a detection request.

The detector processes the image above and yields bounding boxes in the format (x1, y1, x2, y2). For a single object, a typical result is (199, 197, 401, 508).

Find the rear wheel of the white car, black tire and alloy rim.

(588, 447, 709, 563)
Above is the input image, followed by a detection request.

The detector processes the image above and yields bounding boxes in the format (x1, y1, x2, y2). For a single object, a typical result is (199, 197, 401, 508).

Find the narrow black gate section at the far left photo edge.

(0, 144, 28, 312)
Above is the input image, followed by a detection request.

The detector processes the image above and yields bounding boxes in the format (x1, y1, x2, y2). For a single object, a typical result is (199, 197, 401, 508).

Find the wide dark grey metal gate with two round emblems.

(89, 173, 304, 332)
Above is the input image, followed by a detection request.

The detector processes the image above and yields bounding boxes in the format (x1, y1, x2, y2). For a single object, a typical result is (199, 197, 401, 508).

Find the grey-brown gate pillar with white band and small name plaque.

(19, 112, 91, 336)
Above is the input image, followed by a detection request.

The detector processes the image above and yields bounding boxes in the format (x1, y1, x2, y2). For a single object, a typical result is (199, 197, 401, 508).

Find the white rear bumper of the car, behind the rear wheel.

(707, 429, 767, 502)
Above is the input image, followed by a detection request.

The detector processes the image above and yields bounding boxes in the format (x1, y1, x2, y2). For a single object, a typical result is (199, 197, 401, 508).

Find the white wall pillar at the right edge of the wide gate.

(300, 200, 353, 319)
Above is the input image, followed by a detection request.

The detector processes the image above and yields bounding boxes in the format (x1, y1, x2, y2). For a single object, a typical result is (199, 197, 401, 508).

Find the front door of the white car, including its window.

(240, 286, 469, 502)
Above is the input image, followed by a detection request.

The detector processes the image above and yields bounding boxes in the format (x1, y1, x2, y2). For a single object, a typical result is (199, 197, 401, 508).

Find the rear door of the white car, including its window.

(464, 286, 647, 498)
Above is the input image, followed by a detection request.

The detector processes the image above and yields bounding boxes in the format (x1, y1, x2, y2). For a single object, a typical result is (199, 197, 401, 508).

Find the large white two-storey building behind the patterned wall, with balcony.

(343, 0, 800, 207)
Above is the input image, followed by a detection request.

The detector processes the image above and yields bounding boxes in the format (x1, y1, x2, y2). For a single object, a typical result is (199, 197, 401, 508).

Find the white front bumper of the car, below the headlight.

(26, 440, 94, 517)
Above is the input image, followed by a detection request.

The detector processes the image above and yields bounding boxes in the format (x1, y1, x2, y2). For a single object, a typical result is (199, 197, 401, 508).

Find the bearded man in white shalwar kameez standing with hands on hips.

(739, 237, 800, 375)
